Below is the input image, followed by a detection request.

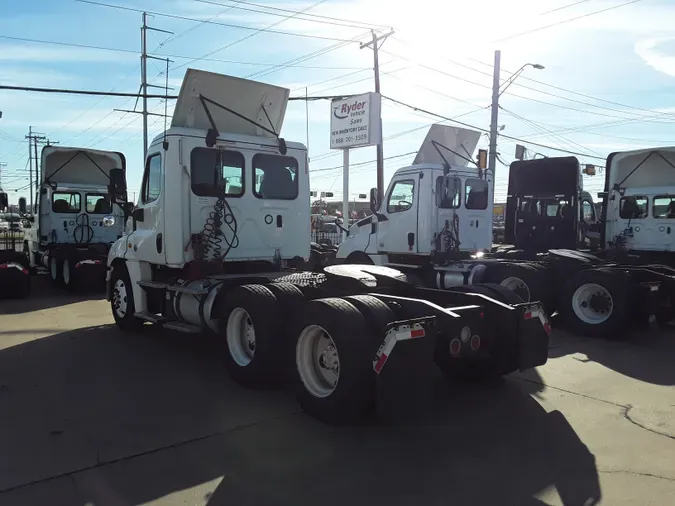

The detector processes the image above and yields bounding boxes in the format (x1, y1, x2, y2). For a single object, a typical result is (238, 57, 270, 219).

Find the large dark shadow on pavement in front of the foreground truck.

(0, 326, 601, 506)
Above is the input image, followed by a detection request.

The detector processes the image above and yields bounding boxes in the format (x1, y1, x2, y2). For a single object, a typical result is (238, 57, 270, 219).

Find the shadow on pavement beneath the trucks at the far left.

(0, 274, 105, 315)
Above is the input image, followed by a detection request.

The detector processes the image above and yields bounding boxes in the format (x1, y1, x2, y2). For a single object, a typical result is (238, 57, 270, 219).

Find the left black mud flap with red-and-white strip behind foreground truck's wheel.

(373, 316, 436, 418)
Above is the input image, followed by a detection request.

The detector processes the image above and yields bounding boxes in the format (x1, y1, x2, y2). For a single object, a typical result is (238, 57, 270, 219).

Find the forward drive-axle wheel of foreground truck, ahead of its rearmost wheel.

(221, 285, 287, 388)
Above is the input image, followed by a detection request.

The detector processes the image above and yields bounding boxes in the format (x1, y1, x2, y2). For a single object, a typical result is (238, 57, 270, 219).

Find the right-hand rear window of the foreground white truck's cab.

(253, 153, 298, 200)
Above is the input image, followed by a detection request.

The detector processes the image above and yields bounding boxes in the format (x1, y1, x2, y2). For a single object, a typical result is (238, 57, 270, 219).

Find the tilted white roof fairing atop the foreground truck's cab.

(171, 69, 290, 137)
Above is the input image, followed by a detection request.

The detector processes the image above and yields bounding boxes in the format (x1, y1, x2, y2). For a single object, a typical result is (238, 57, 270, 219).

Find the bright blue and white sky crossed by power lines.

(0, 0, 675, 206)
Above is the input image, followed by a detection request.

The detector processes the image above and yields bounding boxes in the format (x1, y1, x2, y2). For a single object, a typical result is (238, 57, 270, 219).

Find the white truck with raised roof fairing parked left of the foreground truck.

(21, 146, 126, 290)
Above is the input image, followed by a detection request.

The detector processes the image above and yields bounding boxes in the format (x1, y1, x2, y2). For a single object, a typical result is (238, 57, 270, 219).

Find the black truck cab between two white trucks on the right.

(504, 157, 600, 252)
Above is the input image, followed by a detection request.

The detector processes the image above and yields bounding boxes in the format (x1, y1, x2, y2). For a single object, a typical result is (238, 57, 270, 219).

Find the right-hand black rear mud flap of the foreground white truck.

(515, 302, 551, 372)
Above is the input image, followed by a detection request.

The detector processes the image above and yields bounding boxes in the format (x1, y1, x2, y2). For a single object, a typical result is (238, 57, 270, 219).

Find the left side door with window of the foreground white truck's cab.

(129, 148, 166, 264)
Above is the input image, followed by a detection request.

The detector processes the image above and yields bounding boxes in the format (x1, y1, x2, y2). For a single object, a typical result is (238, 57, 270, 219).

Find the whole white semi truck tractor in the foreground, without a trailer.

(104, 69, 549, 423)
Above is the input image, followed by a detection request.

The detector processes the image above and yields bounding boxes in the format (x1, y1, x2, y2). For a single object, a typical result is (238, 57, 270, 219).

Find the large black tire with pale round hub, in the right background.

(559, 268, 636, 337)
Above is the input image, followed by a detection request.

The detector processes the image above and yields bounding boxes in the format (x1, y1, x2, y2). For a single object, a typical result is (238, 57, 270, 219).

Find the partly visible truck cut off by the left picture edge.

(0, 192, 30, 299)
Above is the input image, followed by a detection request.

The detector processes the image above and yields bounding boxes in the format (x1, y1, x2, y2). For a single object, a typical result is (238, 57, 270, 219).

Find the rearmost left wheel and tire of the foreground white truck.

(295, 298, 377, 425)
